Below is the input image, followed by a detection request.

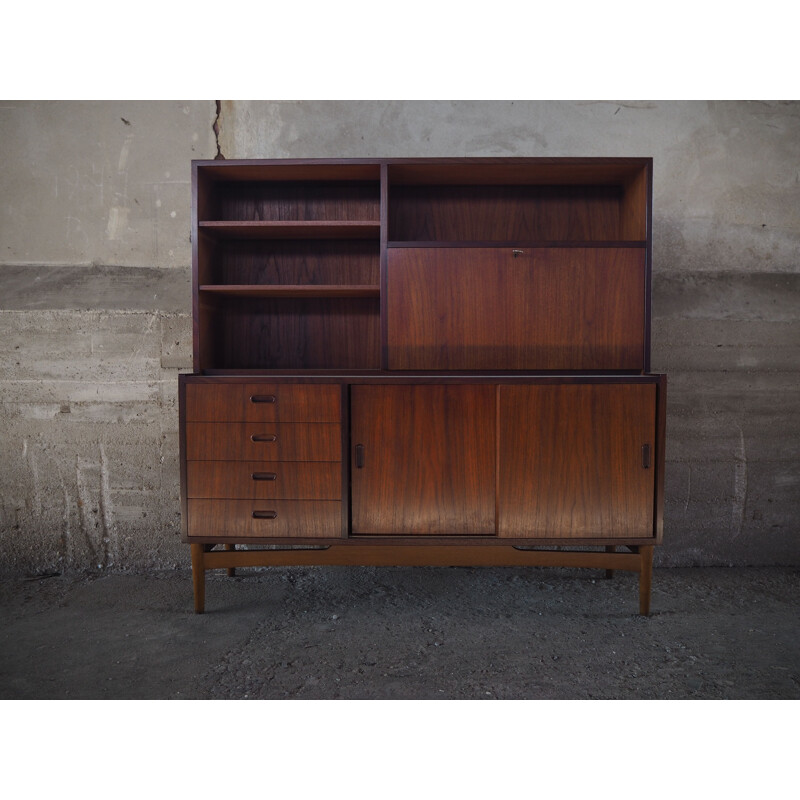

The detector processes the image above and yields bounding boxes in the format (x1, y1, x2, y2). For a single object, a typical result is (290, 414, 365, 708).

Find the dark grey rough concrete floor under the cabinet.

(0, 567, 800, 699)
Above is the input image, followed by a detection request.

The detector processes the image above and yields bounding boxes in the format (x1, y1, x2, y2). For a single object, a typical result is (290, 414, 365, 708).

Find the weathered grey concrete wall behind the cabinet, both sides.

(0, 101, 800, 572)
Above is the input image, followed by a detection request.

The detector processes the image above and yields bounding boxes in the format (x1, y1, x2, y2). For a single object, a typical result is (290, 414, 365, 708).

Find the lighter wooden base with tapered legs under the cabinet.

(191, 543, 654, 616)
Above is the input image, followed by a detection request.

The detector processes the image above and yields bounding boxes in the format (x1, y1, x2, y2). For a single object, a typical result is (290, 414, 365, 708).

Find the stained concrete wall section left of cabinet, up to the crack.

(0, 102, 216, 572)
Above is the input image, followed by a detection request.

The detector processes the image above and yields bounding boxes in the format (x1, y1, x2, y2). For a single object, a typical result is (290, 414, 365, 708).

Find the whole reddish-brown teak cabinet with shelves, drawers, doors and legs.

(179, 158, 666, 614)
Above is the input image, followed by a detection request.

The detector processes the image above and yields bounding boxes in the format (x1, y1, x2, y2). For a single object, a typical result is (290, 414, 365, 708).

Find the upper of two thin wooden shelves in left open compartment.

(198, 220, 381, 239)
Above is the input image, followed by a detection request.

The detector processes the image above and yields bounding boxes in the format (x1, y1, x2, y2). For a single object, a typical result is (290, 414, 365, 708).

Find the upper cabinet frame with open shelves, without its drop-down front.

(192, 158, 652, 374)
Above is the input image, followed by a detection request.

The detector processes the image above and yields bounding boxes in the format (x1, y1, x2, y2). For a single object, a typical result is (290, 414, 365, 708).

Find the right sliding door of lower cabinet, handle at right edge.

(498, 384, 656, 539)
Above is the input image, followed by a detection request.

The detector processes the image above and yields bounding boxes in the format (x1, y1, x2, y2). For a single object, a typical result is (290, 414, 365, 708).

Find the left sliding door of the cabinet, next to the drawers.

(351, 385, 496, 535)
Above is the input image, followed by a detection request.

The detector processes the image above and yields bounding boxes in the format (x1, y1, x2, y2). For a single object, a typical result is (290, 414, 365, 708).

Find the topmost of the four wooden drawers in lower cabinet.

(186, 383, 342, 422)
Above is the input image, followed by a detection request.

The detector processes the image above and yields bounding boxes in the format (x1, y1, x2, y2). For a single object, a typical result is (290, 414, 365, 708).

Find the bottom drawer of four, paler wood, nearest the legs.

(188, 500, 342, 540)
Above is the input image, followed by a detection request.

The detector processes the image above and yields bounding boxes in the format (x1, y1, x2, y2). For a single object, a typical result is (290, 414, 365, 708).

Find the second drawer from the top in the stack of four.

(186, 422, 342, 461)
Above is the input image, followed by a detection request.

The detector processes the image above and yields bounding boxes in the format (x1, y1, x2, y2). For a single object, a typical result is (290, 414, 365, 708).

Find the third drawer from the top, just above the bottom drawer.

(186, 461, 342, 500)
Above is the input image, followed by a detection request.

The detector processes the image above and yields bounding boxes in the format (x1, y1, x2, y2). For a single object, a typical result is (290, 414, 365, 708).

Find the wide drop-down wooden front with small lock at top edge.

(386, 247, 645, 370)
